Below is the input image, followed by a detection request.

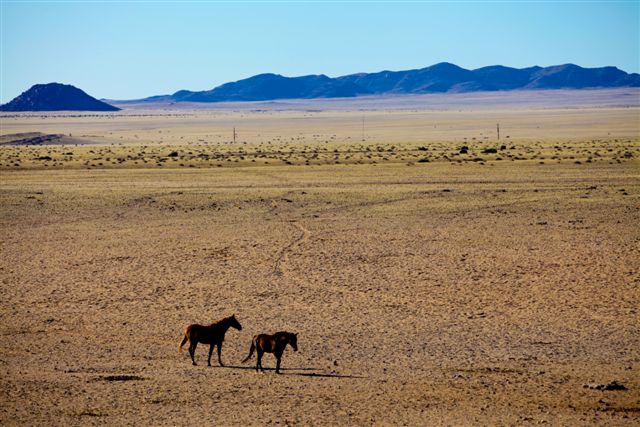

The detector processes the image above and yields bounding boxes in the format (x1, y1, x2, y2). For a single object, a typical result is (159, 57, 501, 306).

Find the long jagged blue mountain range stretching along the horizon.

(136, 62, 640, 102)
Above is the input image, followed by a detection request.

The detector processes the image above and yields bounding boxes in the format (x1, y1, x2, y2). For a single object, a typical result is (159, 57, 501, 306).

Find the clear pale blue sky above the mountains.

(0, 0, 640, 102)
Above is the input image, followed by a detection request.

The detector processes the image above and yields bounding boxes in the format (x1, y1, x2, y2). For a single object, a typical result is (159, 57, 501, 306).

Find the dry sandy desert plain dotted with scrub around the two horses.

(0, 89, 640, 425)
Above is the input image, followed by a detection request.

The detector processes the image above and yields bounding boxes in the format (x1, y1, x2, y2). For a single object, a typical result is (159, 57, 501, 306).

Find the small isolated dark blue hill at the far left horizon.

(0, 83, 120, 111)
